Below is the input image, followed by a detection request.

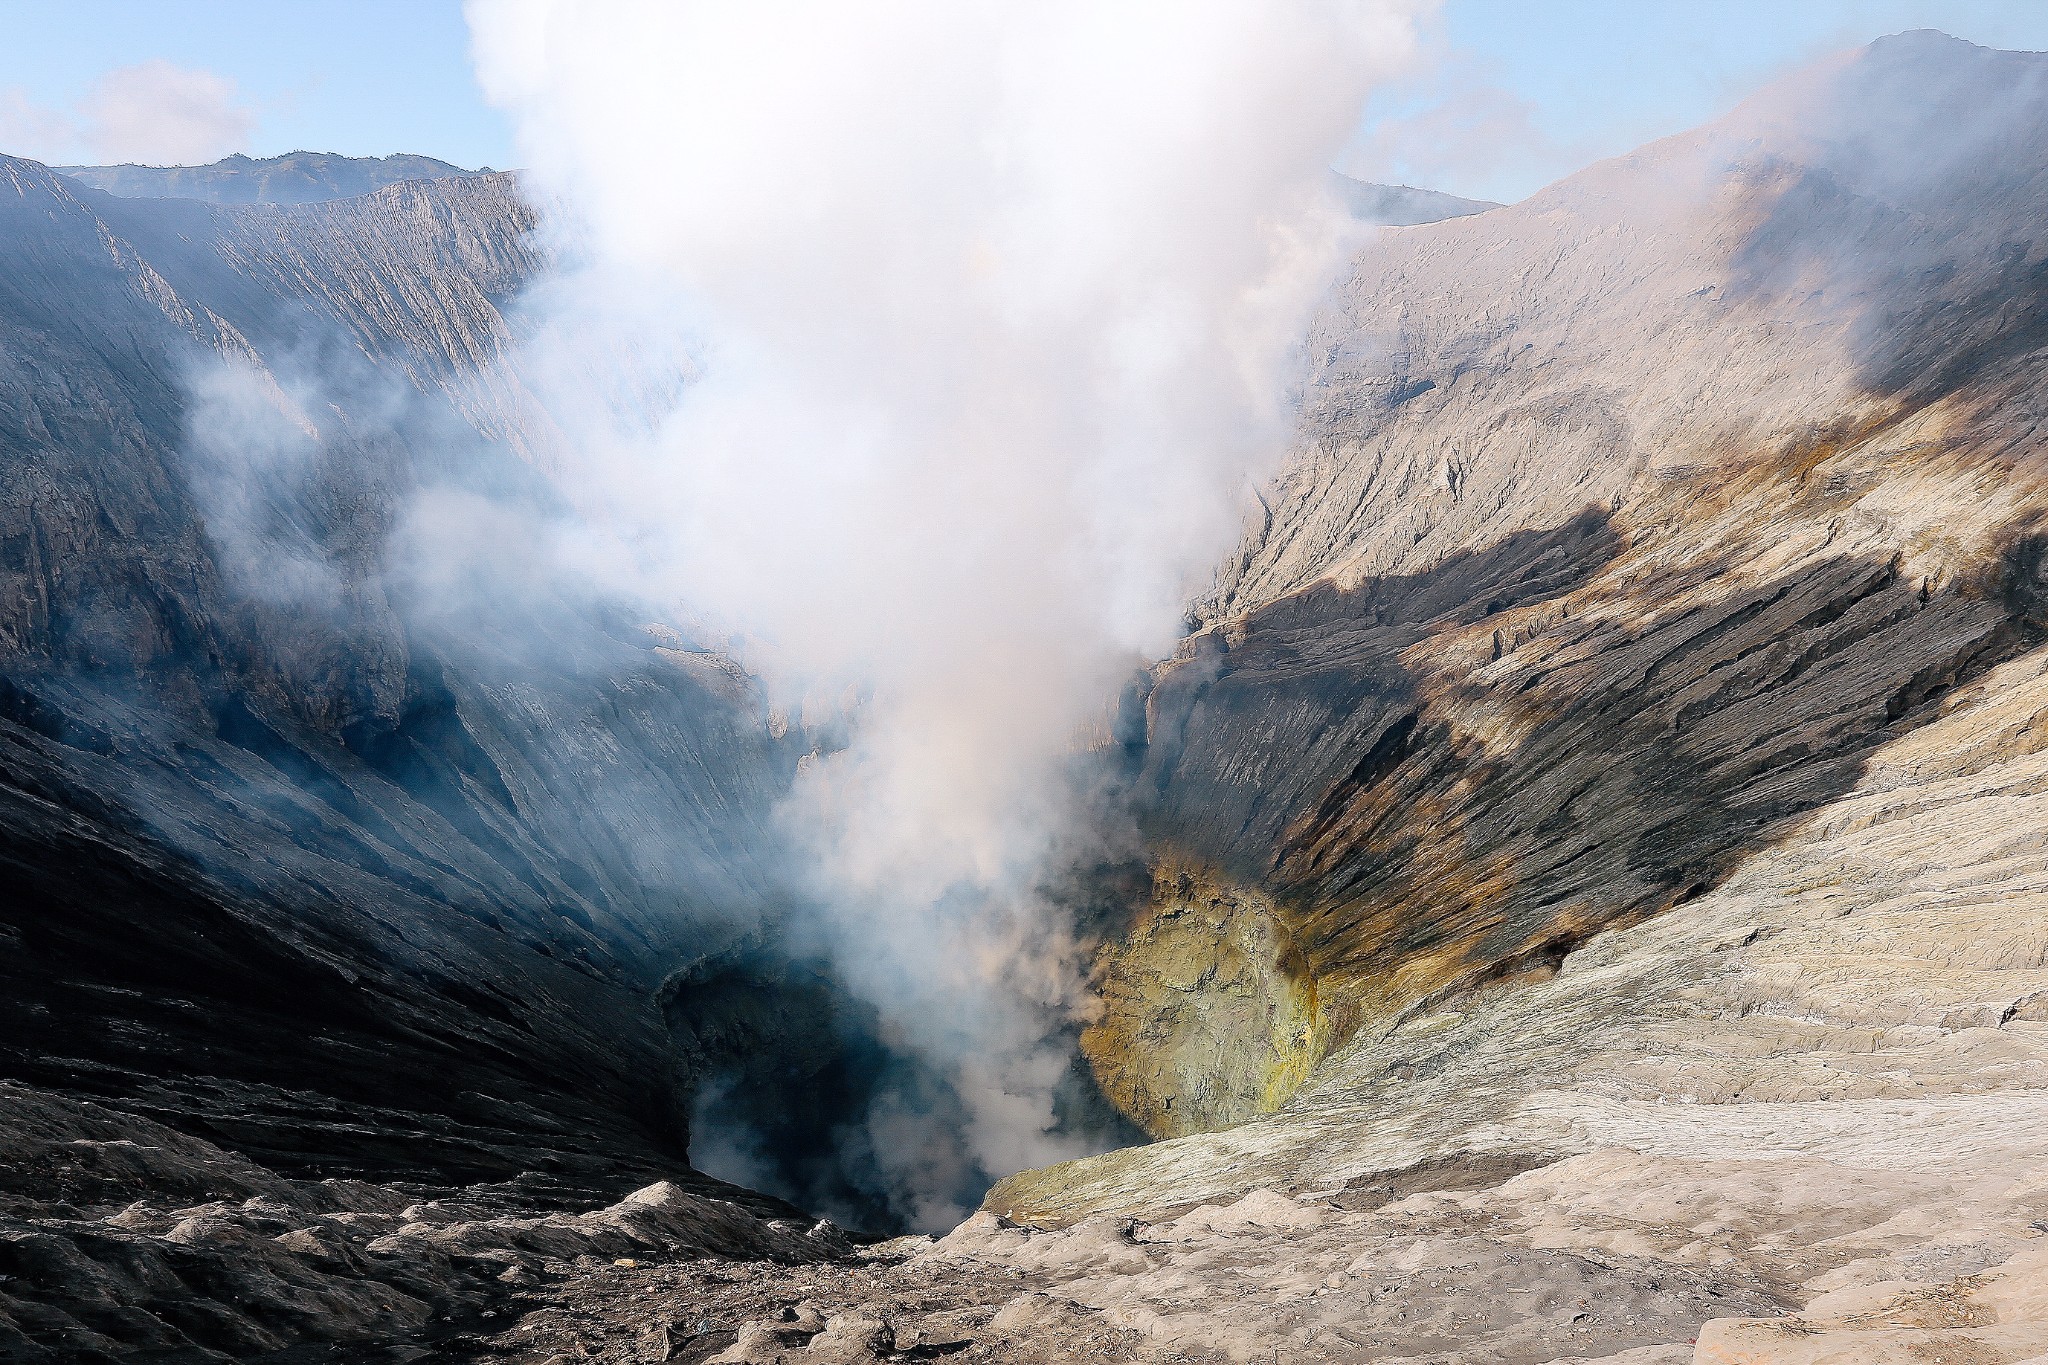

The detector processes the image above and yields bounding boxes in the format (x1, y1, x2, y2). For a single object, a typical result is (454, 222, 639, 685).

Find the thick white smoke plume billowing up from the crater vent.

(469, 0, 1432, 1226)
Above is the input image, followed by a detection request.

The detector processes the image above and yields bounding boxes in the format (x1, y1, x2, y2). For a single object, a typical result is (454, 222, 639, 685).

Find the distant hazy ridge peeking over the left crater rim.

(51, 151, 489, 205)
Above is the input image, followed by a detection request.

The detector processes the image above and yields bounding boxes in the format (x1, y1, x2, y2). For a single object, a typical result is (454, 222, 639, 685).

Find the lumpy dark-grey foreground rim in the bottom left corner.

(0, 1083, 850, 1365)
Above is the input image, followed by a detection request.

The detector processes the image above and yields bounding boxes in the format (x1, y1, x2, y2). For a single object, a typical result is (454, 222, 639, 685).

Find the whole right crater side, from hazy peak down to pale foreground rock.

(962, 33, 2048, 1363)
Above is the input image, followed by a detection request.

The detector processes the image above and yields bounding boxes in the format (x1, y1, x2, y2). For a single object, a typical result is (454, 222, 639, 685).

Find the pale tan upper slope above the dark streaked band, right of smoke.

(1210, 33, 2048, 616)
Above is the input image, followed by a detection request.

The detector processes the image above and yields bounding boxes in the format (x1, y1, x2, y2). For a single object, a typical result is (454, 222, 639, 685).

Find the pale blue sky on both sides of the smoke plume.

(0, 0, 2048, 199)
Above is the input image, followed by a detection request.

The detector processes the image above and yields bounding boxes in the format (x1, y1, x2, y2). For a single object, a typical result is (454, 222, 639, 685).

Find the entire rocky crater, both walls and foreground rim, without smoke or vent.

(12, 21, 2048, 1365)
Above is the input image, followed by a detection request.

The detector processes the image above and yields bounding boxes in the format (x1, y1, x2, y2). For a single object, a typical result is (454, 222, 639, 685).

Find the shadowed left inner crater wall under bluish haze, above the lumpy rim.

(0, 152, 799, 1193)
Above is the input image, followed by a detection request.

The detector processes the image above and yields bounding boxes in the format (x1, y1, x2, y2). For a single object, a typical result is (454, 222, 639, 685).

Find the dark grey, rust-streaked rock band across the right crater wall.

(1122, 497, 2048, 1117)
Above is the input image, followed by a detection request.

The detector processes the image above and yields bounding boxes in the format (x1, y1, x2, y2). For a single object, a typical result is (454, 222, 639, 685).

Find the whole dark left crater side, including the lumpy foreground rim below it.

(0, 144, 860, 1361)
